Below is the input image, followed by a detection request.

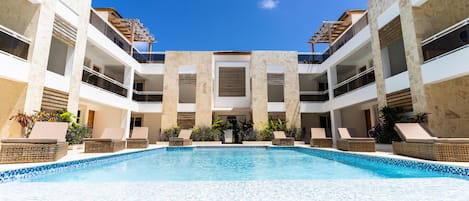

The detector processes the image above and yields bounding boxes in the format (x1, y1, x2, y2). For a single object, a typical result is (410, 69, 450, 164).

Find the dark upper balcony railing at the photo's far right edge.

(422, 18, 469, 62)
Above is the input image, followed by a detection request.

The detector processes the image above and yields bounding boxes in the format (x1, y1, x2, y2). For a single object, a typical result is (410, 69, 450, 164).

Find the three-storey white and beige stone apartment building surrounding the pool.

(0, 0, 469, 143)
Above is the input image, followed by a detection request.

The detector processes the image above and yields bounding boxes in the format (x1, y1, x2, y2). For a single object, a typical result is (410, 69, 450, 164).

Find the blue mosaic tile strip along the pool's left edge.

(0, 148, 166, 184)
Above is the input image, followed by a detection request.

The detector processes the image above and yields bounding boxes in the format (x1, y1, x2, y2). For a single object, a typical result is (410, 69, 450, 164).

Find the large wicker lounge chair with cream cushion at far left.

(0, 122, 68, 163)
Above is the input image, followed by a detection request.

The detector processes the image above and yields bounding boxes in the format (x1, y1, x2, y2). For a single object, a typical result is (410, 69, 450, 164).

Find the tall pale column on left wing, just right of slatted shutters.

(66, 0, 91, 114)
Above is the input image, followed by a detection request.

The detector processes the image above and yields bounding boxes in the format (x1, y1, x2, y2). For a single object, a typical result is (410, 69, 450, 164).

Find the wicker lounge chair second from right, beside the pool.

(337, 128, 376, 152)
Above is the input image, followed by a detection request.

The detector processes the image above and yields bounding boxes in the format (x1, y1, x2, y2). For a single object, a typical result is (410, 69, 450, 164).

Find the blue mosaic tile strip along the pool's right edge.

(287, 147, 469, 180)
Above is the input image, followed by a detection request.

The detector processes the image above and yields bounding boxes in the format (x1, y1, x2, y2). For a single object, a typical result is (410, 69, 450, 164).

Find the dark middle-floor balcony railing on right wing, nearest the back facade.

(334, 67, 375, 97)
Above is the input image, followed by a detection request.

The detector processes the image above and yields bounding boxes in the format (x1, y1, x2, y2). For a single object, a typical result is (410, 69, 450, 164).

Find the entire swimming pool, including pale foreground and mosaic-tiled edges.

(0, 147, 469, 201)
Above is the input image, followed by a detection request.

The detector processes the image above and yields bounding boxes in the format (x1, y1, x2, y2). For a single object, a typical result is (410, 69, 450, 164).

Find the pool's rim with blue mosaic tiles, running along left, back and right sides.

(0, 145, 469, 184)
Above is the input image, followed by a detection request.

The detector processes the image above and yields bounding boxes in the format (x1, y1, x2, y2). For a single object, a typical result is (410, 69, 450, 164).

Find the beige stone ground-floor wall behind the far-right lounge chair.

(425, 76, 469, 138)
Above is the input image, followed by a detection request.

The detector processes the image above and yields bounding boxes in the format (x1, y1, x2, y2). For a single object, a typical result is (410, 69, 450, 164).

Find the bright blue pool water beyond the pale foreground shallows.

(28, 147, 450, 182)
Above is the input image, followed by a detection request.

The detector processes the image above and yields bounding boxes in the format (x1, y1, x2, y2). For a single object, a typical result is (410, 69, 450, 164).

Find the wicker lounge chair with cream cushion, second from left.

(83, 128, 125, 153)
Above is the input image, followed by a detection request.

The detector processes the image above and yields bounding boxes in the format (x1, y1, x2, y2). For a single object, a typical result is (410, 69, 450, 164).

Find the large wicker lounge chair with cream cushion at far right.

(392, 123, 469, 162)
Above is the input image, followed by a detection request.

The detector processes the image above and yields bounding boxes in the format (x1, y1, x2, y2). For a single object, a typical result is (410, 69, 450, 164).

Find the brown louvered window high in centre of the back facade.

(218, 67, 246, 97)
